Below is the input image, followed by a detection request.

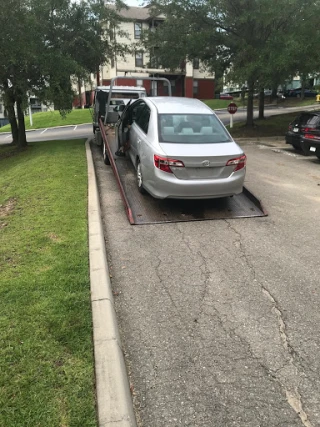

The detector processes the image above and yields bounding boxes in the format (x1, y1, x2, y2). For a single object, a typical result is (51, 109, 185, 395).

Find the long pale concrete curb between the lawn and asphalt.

(86, 139, 137, 427)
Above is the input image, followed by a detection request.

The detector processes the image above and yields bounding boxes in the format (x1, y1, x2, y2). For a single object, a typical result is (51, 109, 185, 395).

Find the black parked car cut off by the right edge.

(286, 111, 320, 159)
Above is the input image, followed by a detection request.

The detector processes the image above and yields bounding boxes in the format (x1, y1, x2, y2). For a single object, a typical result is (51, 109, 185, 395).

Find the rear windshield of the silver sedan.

(159, 114, 232, 144)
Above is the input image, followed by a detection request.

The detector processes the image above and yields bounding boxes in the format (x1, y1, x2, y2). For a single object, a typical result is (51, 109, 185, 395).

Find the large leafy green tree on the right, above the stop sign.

(144, 0, 319, 126)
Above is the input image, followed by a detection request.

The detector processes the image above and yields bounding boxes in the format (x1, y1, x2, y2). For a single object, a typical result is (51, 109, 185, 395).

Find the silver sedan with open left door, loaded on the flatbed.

(116, 97, 246, 199)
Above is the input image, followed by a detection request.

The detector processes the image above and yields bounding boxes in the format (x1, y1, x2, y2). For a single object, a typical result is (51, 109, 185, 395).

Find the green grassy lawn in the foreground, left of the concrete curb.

(0, 140, 97, 427)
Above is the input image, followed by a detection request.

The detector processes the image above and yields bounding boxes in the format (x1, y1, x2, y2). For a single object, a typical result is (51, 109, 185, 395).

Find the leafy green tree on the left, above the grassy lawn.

(0, 0, 127, 147)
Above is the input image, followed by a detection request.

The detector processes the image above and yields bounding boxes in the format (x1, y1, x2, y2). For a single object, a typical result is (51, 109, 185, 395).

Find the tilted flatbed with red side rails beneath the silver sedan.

(95, 120, 267, 224)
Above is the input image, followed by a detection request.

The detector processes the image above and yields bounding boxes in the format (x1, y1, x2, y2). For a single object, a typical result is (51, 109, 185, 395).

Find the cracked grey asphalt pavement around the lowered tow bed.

(93, 142, 320, 427)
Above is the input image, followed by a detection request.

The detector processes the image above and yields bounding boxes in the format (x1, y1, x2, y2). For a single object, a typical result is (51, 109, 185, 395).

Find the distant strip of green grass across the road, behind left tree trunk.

(0, 108, 92, 132)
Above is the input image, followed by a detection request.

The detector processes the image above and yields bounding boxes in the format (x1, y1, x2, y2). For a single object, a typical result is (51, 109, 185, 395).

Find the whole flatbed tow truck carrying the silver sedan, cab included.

(93, 76, 267, 224)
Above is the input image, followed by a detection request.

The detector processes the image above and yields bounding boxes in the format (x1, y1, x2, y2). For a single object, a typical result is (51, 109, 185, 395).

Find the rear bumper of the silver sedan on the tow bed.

(144, 168, 246, 199)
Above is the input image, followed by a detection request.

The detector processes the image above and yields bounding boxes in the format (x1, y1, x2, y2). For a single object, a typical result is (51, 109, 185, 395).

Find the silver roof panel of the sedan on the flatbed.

(144, 96, 213, 114)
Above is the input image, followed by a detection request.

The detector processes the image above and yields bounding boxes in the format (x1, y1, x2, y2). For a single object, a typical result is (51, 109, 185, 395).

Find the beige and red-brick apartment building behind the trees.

(99, 5, 214, 99)
